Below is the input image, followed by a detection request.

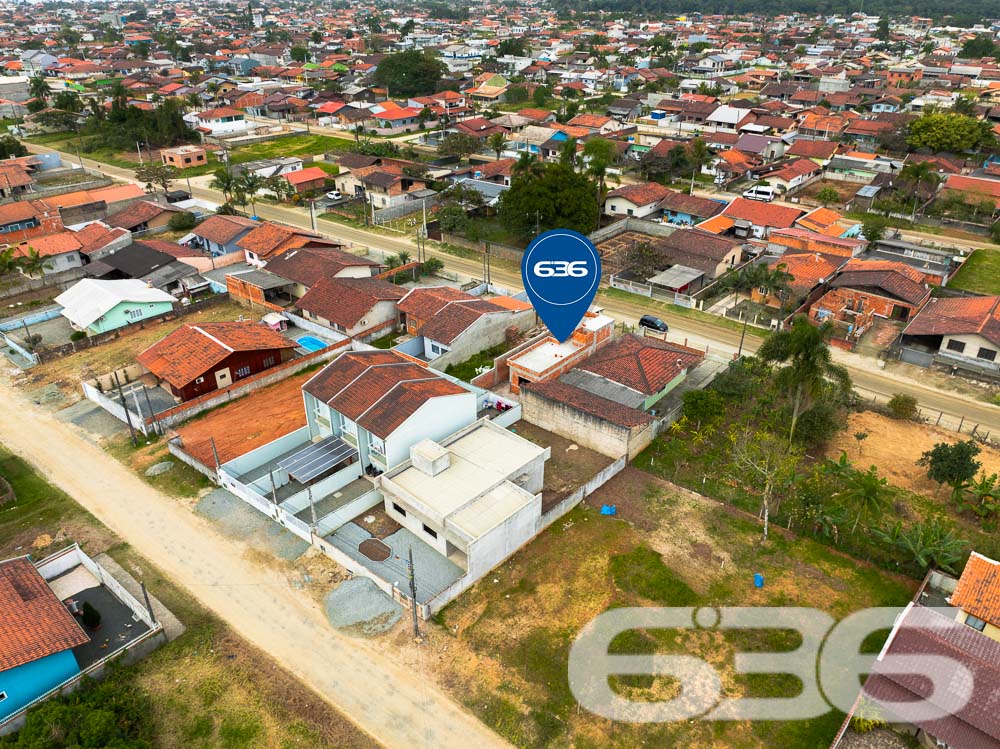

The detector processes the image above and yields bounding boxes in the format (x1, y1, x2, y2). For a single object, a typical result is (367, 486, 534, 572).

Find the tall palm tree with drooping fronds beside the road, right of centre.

(757, 315, 851, 443)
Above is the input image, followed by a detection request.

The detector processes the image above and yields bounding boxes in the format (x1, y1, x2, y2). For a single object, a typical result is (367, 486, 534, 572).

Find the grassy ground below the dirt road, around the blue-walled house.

(0, 447, 377, 749)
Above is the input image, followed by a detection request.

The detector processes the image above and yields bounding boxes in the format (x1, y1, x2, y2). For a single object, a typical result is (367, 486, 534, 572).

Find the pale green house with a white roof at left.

(55, 278, 177, 335)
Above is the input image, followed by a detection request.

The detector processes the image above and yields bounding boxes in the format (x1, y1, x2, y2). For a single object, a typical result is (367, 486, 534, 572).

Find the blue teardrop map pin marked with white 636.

(521, 229, 601, 343)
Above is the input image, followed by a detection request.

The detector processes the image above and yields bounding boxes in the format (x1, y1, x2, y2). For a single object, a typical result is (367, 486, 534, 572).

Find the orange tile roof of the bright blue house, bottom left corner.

(0, 557, 90, 671)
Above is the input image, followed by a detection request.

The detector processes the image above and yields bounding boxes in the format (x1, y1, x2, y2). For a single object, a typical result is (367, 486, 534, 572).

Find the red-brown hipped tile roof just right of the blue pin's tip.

(578, 335, 705, 395)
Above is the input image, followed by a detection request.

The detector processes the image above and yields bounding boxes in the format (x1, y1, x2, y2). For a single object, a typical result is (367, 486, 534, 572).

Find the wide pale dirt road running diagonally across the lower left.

(0, 381, 507, 749)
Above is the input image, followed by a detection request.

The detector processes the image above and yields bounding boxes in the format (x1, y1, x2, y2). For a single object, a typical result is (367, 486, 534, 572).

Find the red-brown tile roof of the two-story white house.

(302, 351, 469, 439)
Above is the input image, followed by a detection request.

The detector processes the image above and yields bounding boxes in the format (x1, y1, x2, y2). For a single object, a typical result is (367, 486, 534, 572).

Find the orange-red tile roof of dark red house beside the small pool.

(137, 322, 296, 389)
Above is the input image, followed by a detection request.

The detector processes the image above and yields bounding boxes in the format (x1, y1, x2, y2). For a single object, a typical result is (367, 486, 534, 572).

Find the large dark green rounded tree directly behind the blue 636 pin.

(500, 162, 598, 239)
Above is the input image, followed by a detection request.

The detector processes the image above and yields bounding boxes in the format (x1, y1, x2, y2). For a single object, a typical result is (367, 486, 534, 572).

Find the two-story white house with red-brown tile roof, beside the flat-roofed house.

(302, 350, 477, 472)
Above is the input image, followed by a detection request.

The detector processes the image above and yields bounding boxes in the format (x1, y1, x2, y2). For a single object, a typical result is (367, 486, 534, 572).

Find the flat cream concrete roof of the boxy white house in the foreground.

(386, 421, 547, 540)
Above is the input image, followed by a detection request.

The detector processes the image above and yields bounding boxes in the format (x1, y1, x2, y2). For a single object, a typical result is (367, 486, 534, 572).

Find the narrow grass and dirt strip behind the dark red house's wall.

(17, 301, 247, 408)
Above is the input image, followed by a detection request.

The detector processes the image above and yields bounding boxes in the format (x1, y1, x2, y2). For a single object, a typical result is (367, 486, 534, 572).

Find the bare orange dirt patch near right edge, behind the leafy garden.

(826, 411, 1000, 495)
